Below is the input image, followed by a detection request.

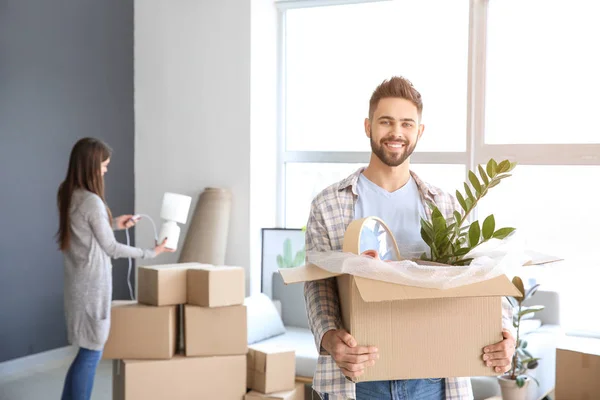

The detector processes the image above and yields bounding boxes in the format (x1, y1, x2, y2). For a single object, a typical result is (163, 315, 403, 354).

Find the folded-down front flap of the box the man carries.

(354, 275, 520, 302)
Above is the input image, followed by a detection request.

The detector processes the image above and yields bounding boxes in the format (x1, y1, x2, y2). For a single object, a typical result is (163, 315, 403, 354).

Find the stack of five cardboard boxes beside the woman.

(103, 263, 248, 400)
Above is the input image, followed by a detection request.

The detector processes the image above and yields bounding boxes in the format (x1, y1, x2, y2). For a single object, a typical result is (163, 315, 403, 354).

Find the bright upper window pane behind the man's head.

(286, 0, 469, 151)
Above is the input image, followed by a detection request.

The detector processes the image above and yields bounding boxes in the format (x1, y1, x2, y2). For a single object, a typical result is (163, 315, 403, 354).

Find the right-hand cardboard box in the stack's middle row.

(184, 305, 248, 356)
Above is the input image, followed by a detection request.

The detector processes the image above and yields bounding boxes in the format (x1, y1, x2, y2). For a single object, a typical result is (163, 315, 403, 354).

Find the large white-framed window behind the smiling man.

(278, 0, 600, 336)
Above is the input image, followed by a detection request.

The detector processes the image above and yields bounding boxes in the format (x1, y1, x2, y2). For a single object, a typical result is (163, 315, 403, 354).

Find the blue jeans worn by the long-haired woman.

(61, 347, 102, 400)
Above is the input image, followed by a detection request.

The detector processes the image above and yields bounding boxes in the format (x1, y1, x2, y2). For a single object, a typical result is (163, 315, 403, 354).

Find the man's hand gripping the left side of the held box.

(321, 329, 379, 379)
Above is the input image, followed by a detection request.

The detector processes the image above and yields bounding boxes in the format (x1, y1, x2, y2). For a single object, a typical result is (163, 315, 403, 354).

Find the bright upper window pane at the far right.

(485, 0, 600, 144)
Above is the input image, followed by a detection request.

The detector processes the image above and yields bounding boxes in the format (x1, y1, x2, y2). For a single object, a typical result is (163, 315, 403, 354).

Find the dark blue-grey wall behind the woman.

(0, 0, 134, 362)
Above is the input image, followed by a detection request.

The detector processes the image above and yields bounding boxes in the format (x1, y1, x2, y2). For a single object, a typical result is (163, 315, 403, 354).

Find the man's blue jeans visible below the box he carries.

(324, 379, 446, 400)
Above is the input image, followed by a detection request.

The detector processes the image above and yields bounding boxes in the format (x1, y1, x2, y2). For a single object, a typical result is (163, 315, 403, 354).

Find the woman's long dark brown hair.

(56, 138, 112, 251)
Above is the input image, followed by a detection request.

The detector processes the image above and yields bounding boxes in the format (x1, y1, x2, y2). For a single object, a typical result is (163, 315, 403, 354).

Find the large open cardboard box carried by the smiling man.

(280, 264, 519, 382)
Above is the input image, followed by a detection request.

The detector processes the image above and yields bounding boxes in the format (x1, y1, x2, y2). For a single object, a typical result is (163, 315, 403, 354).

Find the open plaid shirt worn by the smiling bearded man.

(304, 168, 513, 400)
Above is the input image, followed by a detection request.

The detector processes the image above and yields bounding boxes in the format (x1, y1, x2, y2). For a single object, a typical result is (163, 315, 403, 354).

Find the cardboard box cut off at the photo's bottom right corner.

(552, 337, 600, 400)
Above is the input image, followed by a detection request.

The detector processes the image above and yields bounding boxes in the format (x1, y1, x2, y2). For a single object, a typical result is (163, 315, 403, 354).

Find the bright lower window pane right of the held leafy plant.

(479, 165, 600, 333)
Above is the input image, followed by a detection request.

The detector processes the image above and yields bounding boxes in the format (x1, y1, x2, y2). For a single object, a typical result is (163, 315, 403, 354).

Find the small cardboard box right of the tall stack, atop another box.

(247, 344, 296, 393)
